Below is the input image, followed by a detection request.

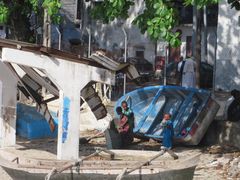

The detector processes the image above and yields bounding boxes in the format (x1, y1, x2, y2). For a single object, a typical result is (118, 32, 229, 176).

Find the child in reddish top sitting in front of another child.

(115, 107, 133, 146)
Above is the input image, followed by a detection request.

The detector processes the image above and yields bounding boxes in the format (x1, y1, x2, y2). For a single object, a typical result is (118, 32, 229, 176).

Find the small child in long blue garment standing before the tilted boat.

(161, 114, 174, 149)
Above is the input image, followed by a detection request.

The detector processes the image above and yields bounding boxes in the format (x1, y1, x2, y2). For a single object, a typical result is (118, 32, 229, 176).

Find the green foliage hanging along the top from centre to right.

(92, 0, 218, 46)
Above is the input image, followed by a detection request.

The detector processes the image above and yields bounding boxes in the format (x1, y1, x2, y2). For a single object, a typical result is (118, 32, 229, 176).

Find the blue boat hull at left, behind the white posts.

(16, 103, 58, 140)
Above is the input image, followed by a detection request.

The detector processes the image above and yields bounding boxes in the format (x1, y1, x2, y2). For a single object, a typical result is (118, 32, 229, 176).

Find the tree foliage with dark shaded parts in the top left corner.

(0, 0, 61, 42)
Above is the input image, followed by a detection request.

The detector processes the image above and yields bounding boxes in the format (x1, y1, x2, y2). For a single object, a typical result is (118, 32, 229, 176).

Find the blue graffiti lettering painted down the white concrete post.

(62, 97, 70, 143)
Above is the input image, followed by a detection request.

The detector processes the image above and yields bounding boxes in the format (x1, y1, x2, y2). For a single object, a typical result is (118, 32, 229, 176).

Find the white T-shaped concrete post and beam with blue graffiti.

(2, 48, 115, 159)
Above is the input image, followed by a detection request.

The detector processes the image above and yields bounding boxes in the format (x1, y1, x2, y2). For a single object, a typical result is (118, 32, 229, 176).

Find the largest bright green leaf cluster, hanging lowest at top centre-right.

(133, 0, 180, 46)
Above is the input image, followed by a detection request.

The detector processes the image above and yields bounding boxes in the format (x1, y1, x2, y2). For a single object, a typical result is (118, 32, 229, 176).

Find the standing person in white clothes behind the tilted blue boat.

(178, 57, 196, 88)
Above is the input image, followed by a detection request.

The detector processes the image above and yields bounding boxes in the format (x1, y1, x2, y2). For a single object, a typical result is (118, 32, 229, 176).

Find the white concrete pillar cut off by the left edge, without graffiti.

(0, 61, 17, 147)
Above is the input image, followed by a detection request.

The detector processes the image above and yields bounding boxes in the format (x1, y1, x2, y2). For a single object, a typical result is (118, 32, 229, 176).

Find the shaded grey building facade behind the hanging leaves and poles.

(56, 0, 216, 69)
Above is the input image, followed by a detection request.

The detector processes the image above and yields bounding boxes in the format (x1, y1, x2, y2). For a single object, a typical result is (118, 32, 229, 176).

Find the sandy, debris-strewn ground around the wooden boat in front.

(0, 132, 240, 180)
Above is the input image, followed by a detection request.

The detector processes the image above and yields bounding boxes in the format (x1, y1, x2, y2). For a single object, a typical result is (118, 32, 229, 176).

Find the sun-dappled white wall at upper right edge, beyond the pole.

(215, 0, 240, 91)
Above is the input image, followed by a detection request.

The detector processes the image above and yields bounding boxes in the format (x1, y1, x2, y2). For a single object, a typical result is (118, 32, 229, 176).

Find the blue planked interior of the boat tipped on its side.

(115, 86, 210, 140)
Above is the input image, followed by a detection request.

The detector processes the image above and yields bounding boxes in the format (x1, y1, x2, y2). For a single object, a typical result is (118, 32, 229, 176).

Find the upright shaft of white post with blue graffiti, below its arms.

(57, 89, 80, 160)
